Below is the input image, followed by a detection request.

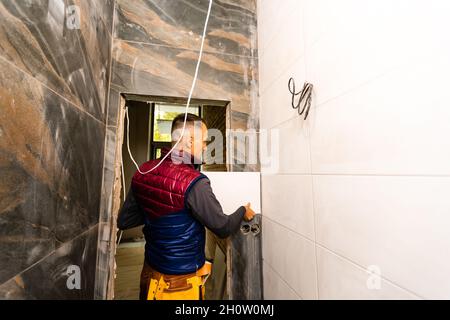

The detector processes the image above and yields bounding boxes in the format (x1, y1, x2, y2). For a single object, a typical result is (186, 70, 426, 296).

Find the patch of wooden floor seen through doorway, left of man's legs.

(114, 242, 145, 300)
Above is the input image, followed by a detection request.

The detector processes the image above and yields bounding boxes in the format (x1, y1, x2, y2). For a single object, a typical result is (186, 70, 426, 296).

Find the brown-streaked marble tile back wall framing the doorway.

(97, 0, 259, 298)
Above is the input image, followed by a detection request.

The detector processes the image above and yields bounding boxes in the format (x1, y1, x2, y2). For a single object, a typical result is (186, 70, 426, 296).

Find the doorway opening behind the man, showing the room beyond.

(114, 94, 231, 300)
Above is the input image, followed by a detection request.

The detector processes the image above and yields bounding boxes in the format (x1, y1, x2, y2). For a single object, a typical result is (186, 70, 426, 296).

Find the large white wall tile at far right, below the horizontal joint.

(313, 176, 450, 299)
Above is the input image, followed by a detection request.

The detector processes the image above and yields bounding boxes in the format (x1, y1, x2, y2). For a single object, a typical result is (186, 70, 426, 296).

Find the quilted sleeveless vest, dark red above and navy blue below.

(131, 150, 206, 274)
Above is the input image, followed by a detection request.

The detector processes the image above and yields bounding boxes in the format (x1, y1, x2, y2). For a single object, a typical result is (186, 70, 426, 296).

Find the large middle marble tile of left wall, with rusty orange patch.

(0, 58, 105, 283)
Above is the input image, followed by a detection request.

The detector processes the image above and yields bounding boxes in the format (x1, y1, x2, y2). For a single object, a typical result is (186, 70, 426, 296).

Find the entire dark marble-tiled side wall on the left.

(0, 0, 113, 299)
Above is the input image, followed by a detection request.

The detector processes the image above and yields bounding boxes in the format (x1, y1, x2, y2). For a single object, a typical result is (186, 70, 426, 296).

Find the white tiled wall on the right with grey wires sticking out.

(258, 0, 450, 299)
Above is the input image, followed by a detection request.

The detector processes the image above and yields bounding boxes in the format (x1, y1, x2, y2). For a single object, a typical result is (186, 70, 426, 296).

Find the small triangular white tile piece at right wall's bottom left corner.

(263, 261, 301, 300)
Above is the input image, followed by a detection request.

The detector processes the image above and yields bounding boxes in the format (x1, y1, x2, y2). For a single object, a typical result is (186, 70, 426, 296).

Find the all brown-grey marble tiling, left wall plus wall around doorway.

(0, 0, 258, 299)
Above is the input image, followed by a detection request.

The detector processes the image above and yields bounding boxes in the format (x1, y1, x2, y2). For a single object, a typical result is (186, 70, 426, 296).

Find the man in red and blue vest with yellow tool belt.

(117, 114, 255, 300)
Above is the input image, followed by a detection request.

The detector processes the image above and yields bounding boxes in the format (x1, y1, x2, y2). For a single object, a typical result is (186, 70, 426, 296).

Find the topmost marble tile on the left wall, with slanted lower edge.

(0, 0, 112, 120)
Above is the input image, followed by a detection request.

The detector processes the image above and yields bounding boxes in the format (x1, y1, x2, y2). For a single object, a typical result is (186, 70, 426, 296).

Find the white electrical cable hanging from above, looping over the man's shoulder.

(125, 0, 213, 175)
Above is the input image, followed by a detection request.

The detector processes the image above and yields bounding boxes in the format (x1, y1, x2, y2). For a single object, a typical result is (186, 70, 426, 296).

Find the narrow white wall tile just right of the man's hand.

(262, 175, 314, 241)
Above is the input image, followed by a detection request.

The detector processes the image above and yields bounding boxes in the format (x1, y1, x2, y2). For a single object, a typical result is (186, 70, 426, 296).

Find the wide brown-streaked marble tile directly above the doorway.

(112, 41, 257, 113)
